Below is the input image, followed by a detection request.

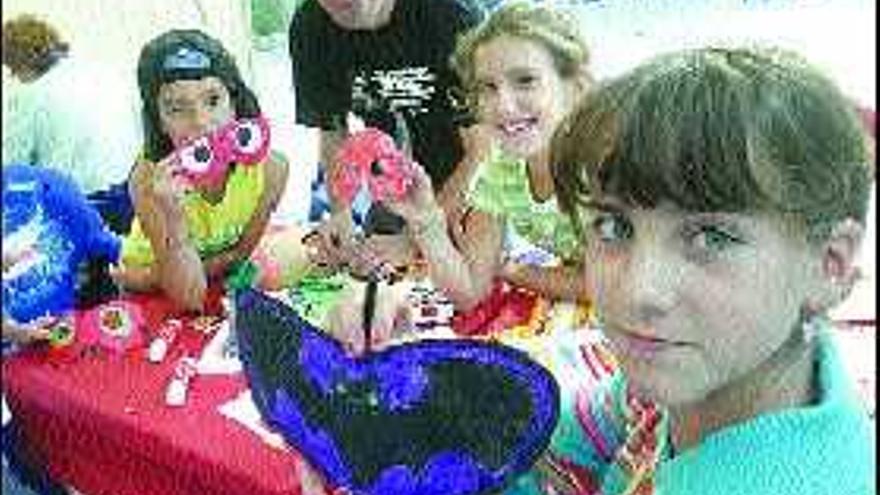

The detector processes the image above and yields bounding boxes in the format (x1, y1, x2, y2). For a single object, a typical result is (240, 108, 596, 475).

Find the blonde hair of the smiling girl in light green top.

(450, 2, 590, 93)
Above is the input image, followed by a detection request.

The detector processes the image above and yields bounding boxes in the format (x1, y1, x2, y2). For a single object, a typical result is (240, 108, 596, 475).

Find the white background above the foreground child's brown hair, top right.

(572, 0, 877, 107)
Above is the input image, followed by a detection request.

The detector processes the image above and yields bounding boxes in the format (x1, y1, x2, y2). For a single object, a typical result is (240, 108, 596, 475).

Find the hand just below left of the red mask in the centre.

(303, 209, 354, 271)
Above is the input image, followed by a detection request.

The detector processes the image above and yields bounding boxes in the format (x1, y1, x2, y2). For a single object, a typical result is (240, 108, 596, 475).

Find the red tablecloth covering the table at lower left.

(3, 297, 308, 495)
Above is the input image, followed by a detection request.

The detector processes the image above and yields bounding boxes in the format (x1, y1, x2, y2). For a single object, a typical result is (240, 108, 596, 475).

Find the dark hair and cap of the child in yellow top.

(137, 29, 260, 161)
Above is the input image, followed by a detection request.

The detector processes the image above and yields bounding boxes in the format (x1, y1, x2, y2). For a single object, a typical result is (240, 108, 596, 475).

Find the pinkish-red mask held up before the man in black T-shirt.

(330, 127, 412, 204)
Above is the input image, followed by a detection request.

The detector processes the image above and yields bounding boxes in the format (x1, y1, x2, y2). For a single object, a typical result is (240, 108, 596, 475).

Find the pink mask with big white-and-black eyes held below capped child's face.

(174, 116, 270, 186)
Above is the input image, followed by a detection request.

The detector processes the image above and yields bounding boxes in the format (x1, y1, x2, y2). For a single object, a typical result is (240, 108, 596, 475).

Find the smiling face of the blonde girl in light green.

(474, 35, 577, 157)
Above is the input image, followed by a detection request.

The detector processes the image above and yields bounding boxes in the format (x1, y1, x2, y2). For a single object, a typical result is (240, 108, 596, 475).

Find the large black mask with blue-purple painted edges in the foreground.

(234, 288, 559, 495)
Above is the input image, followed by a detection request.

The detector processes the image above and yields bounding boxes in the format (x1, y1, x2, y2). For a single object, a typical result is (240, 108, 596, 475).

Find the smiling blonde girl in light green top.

(389, 3, 590, 310)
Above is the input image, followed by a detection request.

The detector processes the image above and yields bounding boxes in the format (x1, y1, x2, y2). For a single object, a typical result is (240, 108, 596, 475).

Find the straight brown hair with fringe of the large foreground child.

(551, 48, 870, 240)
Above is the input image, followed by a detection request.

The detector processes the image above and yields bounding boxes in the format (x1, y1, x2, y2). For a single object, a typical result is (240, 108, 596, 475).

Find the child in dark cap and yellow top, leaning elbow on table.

(116, 30, 287, 311)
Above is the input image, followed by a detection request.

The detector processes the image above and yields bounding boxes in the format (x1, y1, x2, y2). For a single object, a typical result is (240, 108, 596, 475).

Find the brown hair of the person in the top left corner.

(3, 14, 70, 77)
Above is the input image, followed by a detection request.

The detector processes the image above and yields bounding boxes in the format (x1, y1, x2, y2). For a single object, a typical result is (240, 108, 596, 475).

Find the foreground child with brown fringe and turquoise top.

(510, 48, 876, 495)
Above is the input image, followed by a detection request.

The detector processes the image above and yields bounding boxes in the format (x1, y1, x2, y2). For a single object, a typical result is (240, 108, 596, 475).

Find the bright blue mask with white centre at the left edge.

(3, 165, 120, 323)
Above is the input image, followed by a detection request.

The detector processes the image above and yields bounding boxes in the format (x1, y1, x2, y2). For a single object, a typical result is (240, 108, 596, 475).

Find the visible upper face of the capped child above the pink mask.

(158, 77, 235, 146)
